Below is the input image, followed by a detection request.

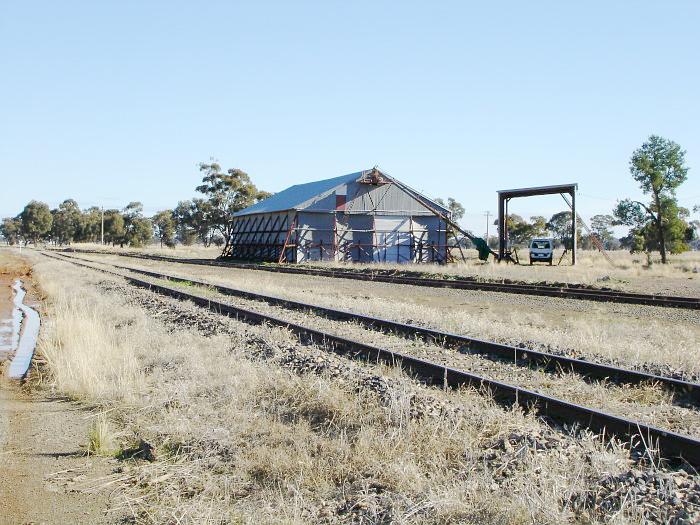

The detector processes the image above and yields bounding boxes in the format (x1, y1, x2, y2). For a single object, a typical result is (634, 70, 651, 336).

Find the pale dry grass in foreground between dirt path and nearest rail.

(26, 252, 672, 524)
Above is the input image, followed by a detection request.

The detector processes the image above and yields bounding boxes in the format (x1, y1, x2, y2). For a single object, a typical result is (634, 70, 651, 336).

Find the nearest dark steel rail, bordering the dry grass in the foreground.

(42, 252, 700, 467)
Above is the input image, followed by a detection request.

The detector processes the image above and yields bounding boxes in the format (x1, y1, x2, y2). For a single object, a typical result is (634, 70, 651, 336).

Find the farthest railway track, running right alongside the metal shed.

(58, 250, 700, 310)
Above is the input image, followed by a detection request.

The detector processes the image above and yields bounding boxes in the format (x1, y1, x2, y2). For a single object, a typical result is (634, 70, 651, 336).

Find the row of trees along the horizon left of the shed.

(0, 162, 270, 254)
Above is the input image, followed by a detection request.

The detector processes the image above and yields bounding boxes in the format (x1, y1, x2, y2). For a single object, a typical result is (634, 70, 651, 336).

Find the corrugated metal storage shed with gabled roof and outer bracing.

(225, 168, 451, 263)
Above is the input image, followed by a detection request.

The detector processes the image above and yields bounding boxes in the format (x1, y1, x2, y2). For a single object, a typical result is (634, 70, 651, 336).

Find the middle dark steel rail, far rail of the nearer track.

(53, 250, 700, 403)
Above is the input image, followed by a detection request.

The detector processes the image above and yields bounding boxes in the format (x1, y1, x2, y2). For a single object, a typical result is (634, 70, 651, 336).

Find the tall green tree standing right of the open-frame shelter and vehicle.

(613, 135, 689, 264)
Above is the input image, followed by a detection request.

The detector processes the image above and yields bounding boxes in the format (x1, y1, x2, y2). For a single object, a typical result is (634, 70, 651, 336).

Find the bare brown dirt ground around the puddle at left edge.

(0, 251, 115, 525)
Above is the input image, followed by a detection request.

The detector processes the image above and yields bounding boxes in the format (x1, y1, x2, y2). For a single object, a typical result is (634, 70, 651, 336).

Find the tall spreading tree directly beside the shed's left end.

(195, 162, 270, 254)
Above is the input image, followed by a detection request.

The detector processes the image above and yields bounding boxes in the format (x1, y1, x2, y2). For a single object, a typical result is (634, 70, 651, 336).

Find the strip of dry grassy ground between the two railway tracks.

(79, 256, 700, 376)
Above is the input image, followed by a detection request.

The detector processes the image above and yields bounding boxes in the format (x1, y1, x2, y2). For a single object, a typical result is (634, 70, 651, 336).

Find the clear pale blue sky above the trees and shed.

(0, 0, 700, 235)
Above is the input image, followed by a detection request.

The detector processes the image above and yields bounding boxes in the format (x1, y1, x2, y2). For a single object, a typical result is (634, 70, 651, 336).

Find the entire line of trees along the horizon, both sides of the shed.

(0, 135, 700, 263)
